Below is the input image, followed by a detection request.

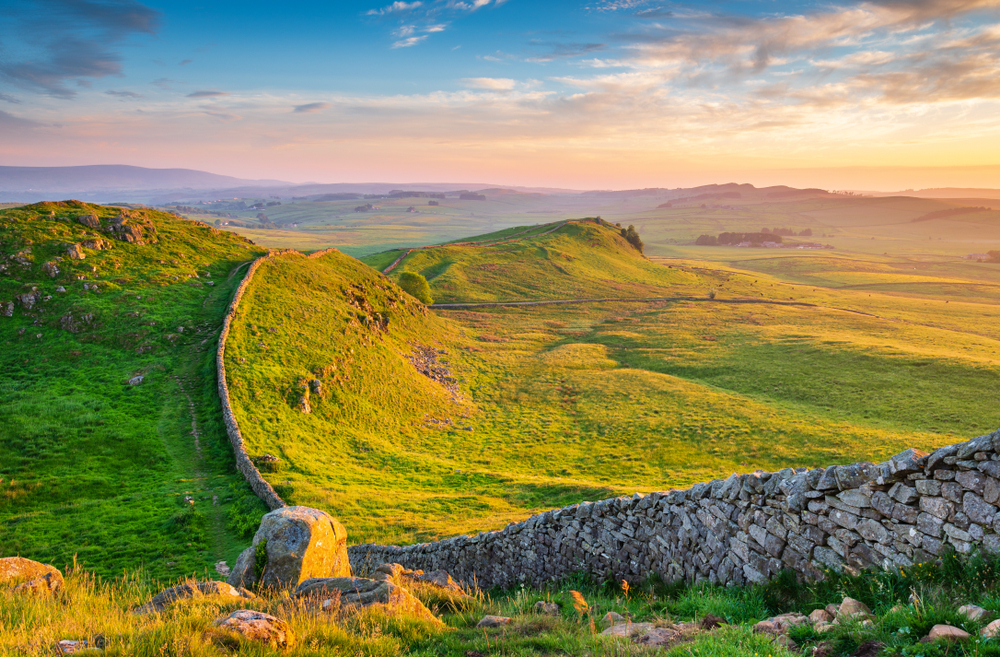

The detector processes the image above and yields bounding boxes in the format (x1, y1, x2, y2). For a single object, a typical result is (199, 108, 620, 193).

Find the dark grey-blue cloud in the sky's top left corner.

(0, 0, 160, 98)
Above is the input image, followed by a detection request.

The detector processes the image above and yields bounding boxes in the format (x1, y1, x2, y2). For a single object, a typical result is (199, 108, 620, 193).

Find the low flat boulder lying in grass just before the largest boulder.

(292, 577, 440, 623)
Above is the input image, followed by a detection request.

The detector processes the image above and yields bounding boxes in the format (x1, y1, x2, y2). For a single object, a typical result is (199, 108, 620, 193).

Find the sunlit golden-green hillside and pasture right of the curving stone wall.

(230, 222, 1000, 542)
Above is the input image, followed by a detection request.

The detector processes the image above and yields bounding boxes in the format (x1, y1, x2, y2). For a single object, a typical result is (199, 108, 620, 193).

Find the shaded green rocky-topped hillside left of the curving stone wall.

(0, 201, 270, 577)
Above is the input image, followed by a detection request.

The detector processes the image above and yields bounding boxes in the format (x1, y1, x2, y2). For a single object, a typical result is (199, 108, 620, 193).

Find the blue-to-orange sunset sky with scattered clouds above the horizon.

(0, 0, 1000, 191)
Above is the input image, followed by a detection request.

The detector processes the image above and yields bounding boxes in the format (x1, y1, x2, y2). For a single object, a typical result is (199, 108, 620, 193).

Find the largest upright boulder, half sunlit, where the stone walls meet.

(227, 506, 351, 591)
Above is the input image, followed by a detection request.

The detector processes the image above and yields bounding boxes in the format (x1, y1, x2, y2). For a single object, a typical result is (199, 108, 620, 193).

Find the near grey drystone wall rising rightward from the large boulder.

(349, 431, 1000, 587)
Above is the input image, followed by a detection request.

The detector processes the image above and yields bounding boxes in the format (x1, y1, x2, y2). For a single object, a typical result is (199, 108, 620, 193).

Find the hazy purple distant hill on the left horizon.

(0, 164, 289, 194)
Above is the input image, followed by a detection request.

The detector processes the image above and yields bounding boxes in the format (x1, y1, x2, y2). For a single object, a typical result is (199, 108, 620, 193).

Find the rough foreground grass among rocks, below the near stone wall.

(9, 555, 1000, 657)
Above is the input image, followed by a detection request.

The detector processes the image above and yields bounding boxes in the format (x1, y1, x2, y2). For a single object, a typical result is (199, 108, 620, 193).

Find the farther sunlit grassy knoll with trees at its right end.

(363, 220, 707, 303)
